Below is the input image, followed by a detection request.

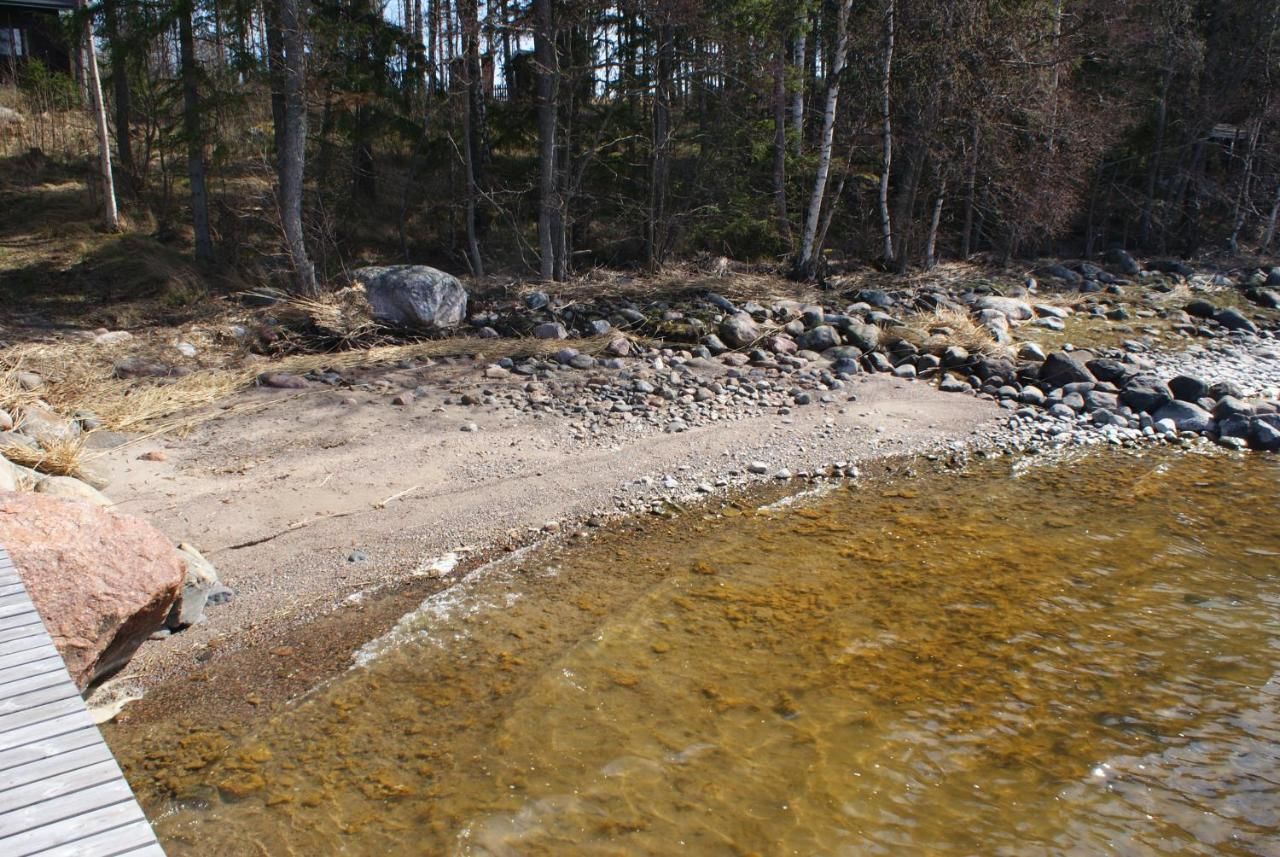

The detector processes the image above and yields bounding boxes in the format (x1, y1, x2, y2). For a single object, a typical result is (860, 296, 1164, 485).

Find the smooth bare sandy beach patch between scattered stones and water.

(91, 361, 1000, 723)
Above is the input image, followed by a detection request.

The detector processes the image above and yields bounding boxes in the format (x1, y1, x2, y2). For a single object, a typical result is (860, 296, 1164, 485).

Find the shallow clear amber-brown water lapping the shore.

(118, 453, 1280, 856)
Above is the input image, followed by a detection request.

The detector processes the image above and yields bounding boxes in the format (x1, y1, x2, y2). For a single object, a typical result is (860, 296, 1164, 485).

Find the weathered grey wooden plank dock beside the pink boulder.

(0, 547, 164, 857)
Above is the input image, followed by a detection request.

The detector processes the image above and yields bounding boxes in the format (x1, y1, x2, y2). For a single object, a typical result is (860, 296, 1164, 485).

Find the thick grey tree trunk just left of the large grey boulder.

(278, 0, 319, 297)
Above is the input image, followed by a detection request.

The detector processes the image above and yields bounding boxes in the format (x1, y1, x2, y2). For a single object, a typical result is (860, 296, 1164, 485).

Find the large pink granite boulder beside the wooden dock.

(0, 492, 184, 689)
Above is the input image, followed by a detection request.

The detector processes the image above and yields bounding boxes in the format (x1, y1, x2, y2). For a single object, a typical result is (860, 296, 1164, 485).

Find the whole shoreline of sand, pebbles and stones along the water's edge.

(90, 263, 1280, 720)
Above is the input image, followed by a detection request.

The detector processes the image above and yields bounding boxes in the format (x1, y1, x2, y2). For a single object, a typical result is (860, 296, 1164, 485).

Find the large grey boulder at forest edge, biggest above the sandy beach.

(351, 265, 467, 327)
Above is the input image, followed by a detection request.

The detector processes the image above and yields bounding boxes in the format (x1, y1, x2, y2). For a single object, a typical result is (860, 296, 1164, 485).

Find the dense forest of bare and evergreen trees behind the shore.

(13, 0, 1280, 293)
